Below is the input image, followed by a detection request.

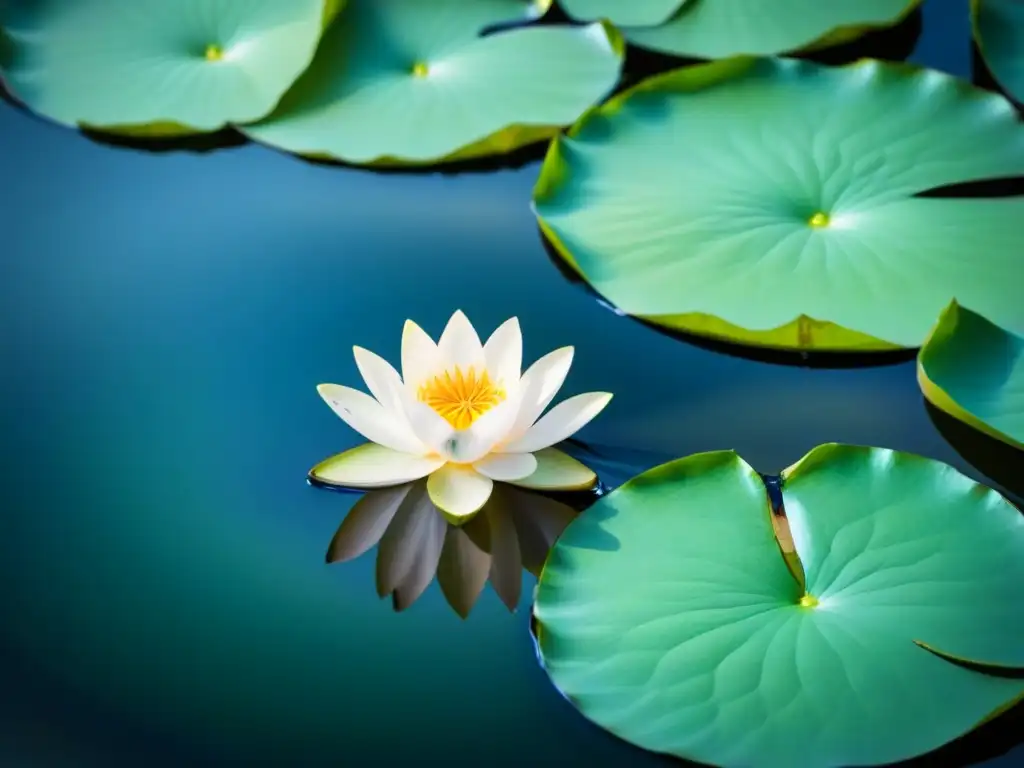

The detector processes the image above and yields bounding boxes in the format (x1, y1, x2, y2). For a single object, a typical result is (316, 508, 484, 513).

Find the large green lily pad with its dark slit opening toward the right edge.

(534, 57, 1024, 351)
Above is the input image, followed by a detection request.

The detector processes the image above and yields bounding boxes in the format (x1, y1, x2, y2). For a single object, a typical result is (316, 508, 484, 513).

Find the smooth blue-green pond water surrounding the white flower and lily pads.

(0, 0, 1024, 767)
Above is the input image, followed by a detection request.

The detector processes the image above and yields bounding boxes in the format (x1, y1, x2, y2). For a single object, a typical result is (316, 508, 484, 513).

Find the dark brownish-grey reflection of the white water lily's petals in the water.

(327, 480, 577, 618)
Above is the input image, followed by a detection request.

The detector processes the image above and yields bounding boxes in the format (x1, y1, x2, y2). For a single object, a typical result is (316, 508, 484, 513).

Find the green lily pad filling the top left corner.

(0, 0, 341, 136)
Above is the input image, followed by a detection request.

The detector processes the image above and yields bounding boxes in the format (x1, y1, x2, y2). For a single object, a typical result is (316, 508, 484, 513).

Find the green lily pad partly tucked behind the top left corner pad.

(245, 0, 624, 166)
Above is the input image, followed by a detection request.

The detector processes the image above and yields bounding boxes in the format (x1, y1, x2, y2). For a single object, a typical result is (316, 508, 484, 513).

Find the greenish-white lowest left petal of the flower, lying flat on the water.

(309, 442, 444, 488)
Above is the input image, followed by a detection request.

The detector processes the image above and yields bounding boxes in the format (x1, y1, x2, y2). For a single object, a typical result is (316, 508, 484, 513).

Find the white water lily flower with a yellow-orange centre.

(309, 311, 611, 522)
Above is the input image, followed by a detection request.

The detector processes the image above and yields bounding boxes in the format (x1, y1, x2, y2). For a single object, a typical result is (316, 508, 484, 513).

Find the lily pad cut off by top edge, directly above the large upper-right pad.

(563, 0, 921, 58)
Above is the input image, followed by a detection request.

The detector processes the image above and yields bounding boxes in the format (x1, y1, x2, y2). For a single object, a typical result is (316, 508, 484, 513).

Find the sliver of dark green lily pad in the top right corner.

(971, 0, 1024, 103)
